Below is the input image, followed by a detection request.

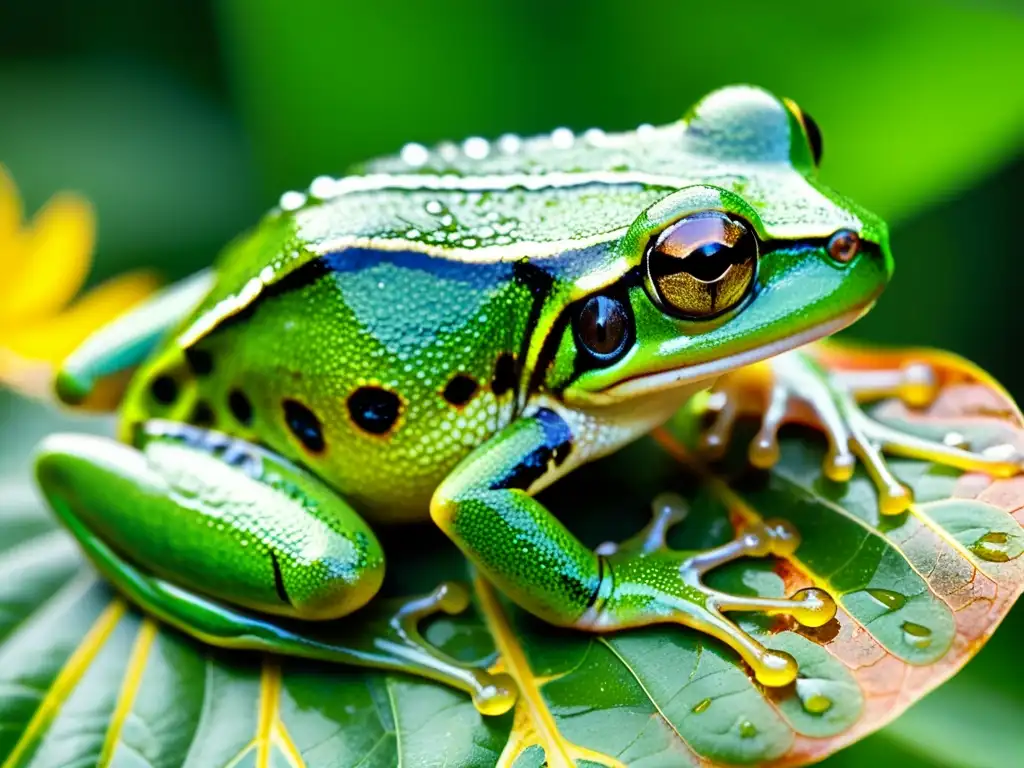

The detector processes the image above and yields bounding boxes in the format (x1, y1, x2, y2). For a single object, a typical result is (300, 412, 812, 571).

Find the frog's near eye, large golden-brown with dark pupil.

(644, 212, 758, 318)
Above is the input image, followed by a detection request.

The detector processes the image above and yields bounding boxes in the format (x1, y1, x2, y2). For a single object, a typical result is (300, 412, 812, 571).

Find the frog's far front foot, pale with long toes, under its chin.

(701, 352, 1024, 514)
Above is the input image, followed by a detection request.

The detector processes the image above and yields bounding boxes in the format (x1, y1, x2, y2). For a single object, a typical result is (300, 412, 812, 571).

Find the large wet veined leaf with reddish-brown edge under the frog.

(0, 352, 1024, 768)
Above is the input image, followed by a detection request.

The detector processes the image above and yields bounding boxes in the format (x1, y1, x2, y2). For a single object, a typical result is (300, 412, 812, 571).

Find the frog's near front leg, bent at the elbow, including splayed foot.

(431, 409, 836, 686)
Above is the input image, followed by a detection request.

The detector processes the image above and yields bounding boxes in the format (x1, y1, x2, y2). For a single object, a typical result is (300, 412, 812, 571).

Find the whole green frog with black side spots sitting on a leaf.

(37, 86, 1021, 715)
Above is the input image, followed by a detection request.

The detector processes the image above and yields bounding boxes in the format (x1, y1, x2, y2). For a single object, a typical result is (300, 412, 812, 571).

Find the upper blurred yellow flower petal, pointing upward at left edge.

(0, 193, 96, 324)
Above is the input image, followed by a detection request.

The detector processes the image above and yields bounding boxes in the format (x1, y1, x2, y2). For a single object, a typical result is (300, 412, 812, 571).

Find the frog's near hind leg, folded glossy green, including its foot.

(36, 422, 515, 714)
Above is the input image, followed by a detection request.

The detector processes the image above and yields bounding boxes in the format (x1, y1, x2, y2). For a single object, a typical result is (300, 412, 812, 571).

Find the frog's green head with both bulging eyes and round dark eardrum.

(547, 87, 892, 407)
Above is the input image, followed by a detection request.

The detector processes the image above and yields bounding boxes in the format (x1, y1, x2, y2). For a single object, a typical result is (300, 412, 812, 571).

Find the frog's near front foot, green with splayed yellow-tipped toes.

(580, 494, 836, 687)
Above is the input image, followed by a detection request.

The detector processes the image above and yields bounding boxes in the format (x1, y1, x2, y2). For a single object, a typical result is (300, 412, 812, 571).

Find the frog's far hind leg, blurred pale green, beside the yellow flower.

(55, 270, 213, 407)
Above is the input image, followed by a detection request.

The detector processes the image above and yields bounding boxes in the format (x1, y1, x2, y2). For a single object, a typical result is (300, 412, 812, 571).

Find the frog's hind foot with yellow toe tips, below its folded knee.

(375, 582, 516, 715)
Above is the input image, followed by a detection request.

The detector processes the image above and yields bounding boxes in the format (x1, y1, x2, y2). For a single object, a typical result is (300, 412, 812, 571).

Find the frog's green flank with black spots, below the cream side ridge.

(124, 231, 552, 519)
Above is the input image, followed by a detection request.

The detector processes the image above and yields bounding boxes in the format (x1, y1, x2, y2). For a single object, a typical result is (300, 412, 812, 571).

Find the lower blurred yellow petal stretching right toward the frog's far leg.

(0, 271, 159, 396)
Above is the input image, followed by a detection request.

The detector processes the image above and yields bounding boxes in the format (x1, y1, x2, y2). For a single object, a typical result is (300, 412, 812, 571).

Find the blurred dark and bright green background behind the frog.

(0, 0, 1024, 767)
